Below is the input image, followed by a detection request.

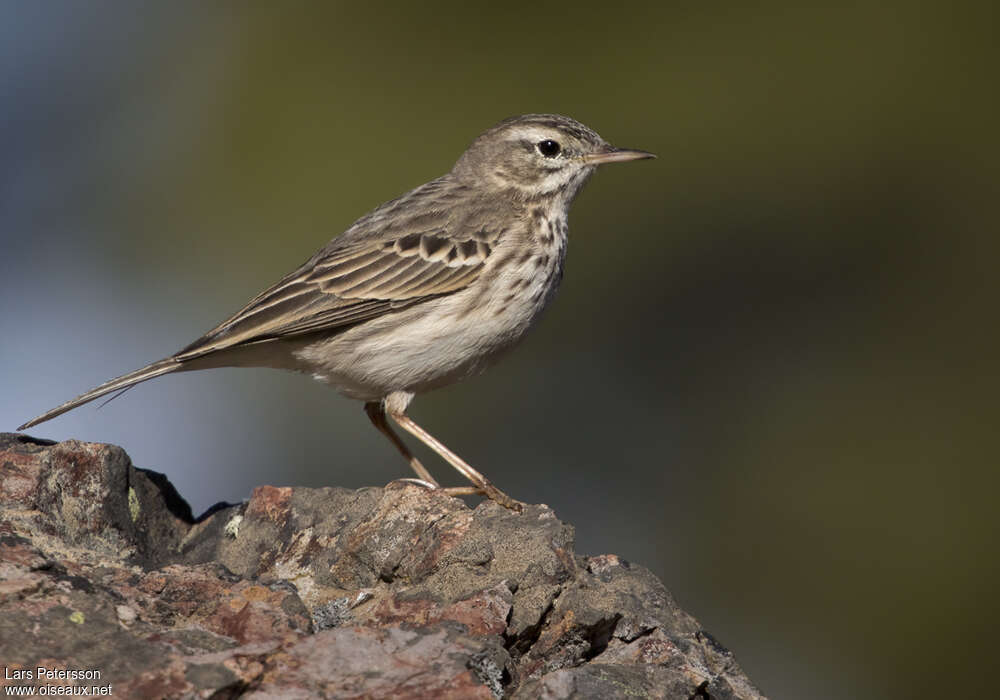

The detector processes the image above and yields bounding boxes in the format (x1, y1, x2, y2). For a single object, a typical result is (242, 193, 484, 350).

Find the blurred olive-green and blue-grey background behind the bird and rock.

(0, 0, 1000, 698)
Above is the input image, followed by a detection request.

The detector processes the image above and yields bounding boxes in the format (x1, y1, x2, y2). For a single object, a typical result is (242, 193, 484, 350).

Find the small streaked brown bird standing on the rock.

(18, 114, 655, 510)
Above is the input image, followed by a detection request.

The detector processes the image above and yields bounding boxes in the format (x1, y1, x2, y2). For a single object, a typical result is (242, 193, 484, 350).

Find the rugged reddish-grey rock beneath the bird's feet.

(0, 434, 761, 699)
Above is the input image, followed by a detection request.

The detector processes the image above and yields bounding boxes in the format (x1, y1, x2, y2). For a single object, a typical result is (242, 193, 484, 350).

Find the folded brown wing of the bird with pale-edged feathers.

(174, 229, 495, 361)
